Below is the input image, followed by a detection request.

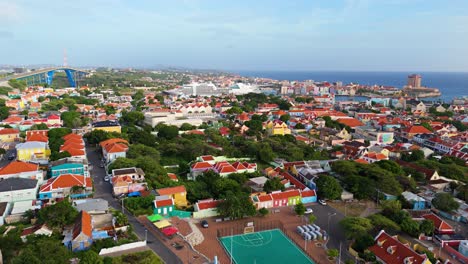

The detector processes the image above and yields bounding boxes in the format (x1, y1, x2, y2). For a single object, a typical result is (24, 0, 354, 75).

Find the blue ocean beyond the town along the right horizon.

(236, 71, 468, 102)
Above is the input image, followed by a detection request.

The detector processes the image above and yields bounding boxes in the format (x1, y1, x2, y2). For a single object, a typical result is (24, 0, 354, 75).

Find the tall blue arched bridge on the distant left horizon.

(6, 67, 89, 87)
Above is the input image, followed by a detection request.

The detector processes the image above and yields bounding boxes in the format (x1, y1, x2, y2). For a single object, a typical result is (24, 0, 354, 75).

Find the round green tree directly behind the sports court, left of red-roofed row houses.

(217, 191, 257, 219)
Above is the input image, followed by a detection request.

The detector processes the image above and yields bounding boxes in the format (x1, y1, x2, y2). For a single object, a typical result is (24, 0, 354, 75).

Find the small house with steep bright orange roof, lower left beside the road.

(63, 211, 93, 252)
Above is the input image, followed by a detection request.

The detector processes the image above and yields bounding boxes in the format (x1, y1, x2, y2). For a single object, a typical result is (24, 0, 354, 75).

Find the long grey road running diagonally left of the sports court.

(86, 146, 182, 264)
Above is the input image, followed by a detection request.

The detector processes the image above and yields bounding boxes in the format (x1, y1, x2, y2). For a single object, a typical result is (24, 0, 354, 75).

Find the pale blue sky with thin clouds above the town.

(0, 0, 468, 72)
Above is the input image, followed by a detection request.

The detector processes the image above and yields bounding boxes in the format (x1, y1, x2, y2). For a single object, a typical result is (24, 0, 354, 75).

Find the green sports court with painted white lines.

(220, 229, 314, 264)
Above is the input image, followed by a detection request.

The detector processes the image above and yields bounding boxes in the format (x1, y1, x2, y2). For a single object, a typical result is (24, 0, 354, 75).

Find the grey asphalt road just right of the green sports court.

(307, 203, 355, 262)
